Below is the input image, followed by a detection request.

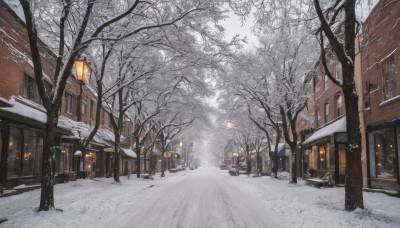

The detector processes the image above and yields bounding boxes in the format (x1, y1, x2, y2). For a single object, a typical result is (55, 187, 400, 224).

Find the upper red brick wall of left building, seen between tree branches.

(0, 5, 112, 130)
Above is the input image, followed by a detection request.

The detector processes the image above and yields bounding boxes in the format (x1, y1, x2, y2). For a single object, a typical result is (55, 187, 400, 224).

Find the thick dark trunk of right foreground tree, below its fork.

(343, 67, 364, 211)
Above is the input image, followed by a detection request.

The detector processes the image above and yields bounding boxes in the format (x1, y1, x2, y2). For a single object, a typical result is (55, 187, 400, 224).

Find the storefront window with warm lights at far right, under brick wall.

(375, 128, 397, 179)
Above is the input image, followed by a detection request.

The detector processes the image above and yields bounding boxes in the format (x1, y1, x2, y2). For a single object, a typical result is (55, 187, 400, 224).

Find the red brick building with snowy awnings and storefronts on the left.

(0, 0, 135, 190)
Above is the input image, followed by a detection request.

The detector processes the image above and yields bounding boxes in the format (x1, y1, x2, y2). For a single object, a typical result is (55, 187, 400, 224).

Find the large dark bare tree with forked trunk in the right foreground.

(314, 0, 364, 211)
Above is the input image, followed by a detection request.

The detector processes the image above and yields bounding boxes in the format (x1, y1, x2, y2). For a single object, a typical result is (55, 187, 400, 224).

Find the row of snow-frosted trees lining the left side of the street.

(20, 0, 237, 211)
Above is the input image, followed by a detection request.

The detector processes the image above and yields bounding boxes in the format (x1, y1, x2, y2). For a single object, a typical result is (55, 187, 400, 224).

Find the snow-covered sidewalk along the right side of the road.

(228, 172, 400, 228)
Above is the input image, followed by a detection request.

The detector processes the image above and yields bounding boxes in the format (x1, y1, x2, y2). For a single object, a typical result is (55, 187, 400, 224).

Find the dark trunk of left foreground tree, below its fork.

(39, 109, 58, 211)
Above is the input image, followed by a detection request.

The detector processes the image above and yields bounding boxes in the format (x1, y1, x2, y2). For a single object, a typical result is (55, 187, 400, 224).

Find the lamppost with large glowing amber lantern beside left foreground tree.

(75, 57, 90, 178)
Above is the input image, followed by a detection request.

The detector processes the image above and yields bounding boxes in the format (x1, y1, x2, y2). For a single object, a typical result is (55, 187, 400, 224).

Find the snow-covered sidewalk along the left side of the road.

(0, 172, 184, 227)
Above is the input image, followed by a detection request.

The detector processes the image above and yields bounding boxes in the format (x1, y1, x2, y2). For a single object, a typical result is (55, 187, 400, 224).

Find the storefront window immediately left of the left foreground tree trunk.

(21, 129, 37, 176)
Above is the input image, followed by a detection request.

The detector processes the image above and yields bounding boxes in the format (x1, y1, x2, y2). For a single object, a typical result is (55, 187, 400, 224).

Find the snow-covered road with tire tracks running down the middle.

(105, 167, 282, 228)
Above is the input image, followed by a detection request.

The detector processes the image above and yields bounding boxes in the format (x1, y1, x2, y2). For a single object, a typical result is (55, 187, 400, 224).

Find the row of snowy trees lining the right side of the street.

(220, 0, 363, 211)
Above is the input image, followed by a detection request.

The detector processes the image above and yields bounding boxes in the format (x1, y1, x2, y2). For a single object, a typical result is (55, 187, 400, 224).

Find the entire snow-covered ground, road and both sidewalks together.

(0, 167, 400, 228)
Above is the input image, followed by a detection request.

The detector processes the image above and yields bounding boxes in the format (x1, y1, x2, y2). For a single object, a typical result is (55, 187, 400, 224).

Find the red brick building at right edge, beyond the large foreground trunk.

(361, 0, 400, 191)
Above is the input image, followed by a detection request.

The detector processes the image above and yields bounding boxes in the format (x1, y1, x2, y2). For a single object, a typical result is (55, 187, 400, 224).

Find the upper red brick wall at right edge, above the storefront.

(361, 1, 400, 125)
